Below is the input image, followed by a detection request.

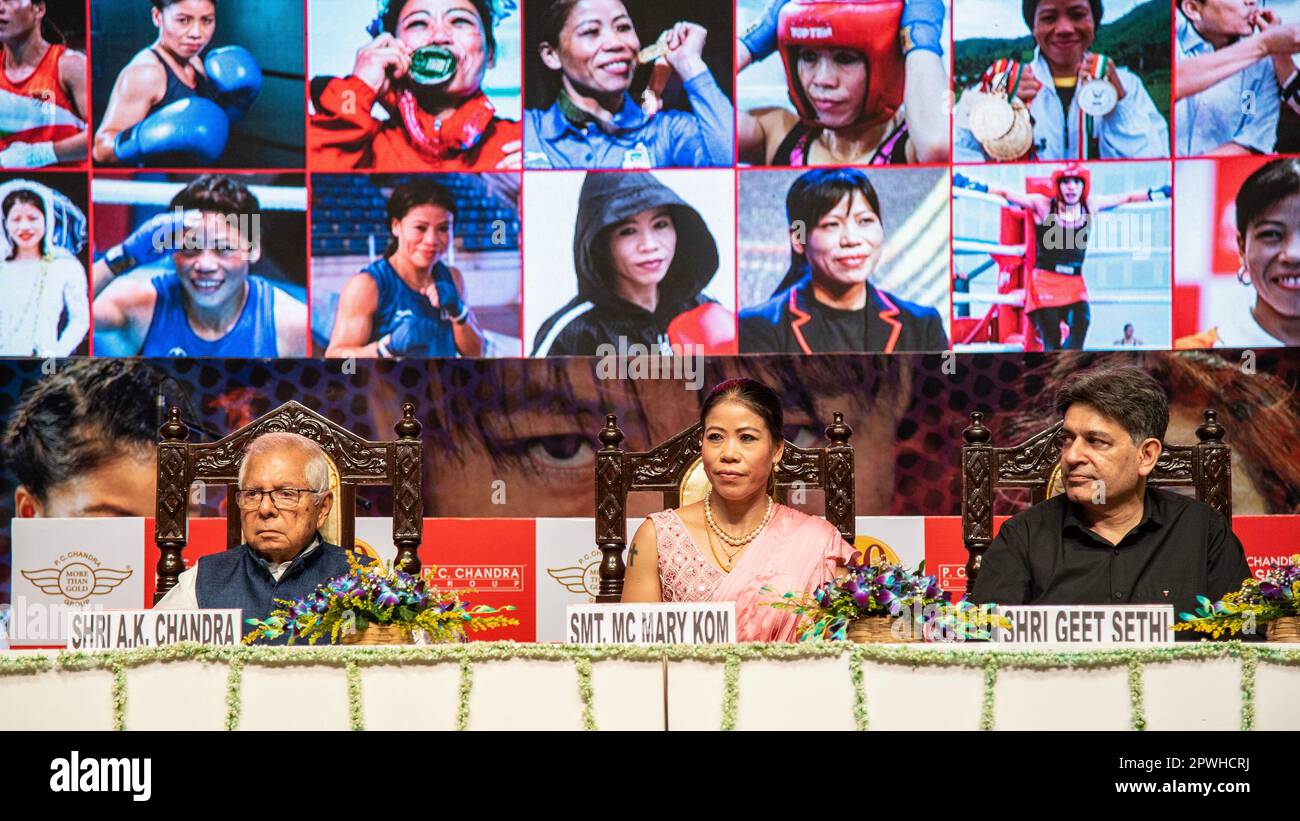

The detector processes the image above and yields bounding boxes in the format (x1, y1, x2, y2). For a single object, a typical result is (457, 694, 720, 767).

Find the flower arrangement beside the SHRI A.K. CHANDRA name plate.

(243, 552, 519, 644)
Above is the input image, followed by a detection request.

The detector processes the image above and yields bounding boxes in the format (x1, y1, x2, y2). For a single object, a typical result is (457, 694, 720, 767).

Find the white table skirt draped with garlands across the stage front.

(0, 643, 1300, 730)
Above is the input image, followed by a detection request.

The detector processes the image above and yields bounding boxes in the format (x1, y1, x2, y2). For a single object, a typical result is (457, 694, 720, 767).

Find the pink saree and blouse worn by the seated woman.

(650, 504, 853, 642)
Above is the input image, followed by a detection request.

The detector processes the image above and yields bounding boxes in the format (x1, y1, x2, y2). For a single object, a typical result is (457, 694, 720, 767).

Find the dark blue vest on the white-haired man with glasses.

(195, 540, 348, 644)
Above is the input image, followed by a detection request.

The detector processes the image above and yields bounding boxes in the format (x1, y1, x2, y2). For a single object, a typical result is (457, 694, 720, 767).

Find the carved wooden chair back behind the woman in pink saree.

(595, 413, 854, 603)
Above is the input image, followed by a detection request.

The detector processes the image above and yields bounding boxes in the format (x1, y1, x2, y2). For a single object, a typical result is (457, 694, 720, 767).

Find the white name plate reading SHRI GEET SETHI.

(993, 604, 1177, 644)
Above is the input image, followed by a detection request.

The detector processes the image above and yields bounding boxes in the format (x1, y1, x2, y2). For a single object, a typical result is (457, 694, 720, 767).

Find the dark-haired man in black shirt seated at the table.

(971, 368, 1251, 633)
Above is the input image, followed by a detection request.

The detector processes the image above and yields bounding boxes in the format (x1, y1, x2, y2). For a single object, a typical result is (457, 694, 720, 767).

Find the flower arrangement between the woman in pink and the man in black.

(763, 551, 1010, 642)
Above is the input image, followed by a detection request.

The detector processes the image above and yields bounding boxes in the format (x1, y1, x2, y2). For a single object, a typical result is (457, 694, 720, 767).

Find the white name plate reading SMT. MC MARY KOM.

(564, 601, 736, 644)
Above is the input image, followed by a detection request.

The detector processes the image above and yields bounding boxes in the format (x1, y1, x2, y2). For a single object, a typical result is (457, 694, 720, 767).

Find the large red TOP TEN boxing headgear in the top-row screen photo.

(776, 0, 904, 125)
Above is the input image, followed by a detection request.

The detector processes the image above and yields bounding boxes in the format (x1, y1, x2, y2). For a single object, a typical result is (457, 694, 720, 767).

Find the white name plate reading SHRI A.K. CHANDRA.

(66, 611, 243, 650)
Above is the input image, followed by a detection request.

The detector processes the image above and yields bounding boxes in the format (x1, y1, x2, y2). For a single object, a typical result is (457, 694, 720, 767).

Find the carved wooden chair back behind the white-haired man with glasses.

(153, 401, 424, 603)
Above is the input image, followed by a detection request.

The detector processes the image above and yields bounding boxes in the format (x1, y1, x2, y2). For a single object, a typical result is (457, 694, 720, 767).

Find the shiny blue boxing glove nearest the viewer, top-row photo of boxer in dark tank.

(113, 97, 230, 165)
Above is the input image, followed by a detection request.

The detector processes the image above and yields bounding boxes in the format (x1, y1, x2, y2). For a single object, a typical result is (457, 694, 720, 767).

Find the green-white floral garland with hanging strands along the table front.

(0, 642, 1300, 730)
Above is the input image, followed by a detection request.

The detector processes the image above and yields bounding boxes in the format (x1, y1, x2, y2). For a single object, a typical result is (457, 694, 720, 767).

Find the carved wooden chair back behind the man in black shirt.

(962, 411, 1232, 590)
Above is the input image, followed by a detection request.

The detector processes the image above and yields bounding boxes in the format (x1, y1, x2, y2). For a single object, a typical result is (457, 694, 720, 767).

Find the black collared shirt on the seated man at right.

(971, 487, 1251, 635)
